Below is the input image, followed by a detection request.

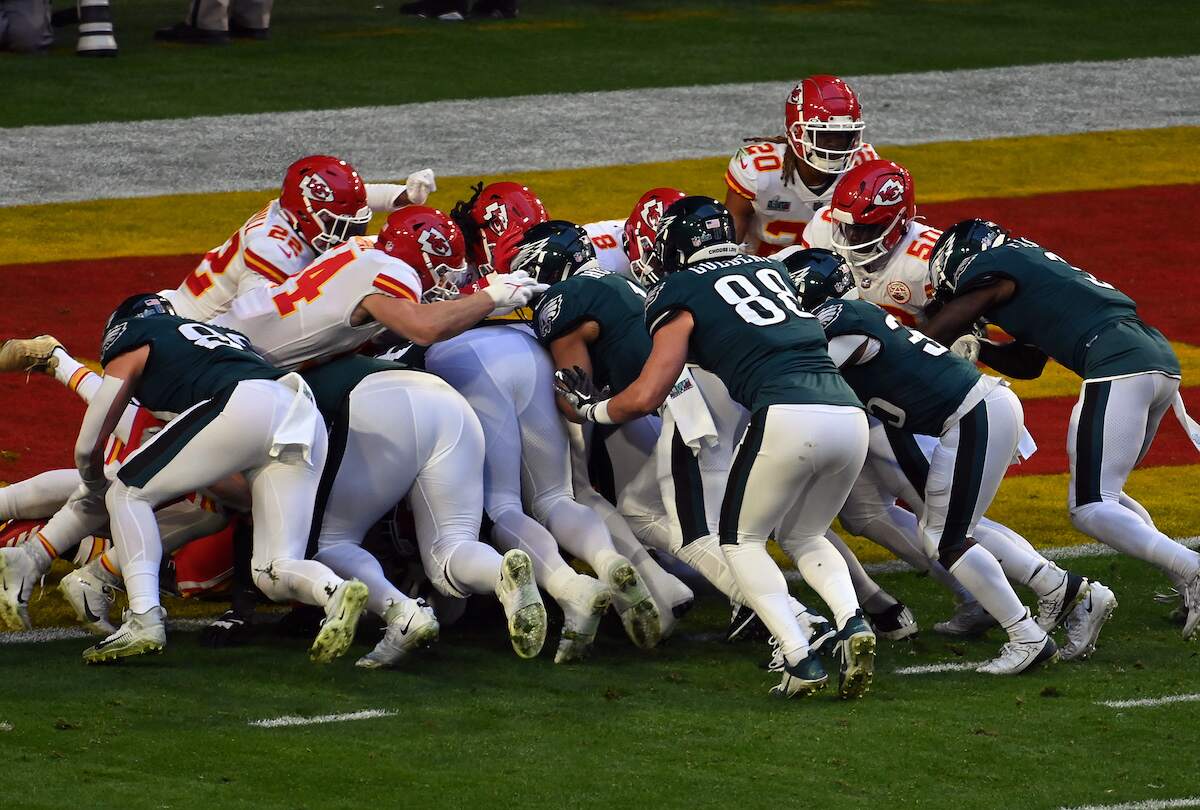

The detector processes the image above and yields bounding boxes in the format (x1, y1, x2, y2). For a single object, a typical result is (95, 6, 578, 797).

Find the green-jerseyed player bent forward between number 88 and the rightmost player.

(793, 252, 1073, 674)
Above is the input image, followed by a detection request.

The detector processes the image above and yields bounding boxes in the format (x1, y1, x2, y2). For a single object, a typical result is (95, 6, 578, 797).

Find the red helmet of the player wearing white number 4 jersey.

(376, 205, 468, 301)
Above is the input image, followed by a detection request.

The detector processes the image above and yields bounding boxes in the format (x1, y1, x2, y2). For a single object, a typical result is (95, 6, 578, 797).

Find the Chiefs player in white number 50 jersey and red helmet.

(803, 160, 942, 326)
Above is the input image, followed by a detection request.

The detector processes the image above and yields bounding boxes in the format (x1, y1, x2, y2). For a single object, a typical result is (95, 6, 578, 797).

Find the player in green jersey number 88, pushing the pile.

(559, 197, 875, 697)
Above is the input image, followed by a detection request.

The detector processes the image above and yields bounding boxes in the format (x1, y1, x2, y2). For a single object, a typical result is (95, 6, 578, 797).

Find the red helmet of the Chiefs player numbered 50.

(829, 160, 917, 268)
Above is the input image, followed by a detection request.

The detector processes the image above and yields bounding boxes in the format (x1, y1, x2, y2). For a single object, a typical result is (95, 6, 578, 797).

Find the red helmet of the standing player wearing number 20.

(784, 74, 866, 174)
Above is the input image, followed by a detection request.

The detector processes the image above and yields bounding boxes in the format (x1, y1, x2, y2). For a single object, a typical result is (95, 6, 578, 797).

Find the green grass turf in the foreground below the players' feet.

(0, 557, 1200, 810)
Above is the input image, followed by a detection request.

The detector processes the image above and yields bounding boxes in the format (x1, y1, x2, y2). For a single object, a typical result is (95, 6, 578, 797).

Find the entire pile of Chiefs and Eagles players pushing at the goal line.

(0, 76, 1200, 697)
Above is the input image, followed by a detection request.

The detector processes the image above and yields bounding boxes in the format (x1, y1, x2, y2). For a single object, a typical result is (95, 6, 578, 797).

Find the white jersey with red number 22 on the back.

(163, 199, 317, 320)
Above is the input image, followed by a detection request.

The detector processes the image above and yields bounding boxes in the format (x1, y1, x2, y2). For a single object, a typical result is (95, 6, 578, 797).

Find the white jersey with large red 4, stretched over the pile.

(212, 236, 421, 371)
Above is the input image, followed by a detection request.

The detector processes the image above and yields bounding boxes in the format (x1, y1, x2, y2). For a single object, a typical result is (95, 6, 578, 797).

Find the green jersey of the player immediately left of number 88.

(533, 270, 650, 394)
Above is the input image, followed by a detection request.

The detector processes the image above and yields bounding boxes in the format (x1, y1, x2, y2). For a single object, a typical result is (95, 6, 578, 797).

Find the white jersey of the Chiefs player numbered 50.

(802, 205, 942, 326)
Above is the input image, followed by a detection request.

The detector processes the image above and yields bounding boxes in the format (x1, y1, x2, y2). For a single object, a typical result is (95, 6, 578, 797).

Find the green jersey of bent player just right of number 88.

(814, 299, 980, 436)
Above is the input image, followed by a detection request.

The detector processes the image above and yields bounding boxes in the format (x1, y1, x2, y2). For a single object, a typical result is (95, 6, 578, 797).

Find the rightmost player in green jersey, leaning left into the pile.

(926, 220, 1200, 638)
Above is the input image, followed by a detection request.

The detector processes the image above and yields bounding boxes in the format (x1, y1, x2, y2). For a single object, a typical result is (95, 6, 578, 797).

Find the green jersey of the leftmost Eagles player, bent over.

(100, 314, 287, 414)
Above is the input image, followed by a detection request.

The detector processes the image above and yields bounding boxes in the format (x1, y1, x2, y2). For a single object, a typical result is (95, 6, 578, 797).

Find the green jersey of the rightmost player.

(956, 239, 1180, 379)
